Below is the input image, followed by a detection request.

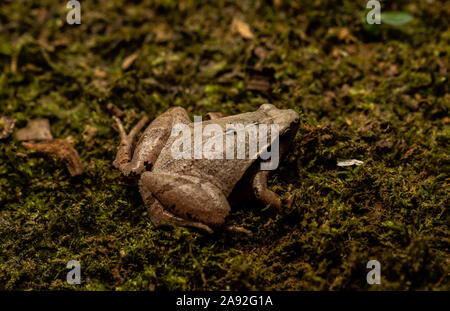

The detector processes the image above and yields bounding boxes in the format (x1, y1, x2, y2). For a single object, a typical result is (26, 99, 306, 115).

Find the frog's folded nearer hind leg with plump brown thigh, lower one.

(140, 172, 230, 231)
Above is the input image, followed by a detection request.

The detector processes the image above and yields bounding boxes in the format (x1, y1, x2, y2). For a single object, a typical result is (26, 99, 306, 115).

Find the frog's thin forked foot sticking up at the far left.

(113, 116, 149, 176)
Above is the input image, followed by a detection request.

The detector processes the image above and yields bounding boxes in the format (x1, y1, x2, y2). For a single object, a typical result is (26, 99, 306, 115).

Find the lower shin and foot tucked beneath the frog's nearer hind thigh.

(139, 176, 213, 233)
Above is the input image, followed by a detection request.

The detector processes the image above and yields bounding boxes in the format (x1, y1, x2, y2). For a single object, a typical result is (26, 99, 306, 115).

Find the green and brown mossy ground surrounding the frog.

(0, 0, 450, 290)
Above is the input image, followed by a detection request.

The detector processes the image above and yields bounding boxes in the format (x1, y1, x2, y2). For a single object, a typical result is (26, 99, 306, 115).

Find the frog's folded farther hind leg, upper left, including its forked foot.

(113, 107, 190, 176)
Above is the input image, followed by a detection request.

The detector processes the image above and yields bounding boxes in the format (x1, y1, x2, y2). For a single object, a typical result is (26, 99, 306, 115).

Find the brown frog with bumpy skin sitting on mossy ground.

(112, 103, 300, 235)
